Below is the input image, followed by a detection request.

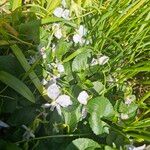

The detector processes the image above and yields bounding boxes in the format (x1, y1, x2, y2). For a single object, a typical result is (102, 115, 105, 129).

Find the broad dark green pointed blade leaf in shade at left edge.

(0, 71, 35, 103)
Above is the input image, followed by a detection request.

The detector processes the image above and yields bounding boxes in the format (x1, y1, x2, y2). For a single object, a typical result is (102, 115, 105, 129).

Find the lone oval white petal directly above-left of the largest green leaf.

(77, 91, 89, 105)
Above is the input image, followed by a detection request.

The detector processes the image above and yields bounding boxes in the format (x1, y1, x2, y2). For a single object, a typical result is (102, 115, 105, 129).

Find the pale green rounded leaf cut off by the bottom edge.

(66, 138, 101, 150)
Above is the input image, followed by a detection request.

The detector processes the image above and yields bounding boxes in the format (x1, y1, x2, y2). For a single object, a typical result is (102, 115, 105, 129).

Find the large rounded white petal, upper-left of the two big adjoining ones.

(47, 83, 60, 100)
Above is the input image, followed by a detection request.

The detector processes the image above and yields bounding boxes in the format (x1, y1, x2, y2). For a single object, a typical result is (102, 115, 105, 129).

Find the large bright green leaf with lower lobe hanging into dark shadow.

(87, 96, 114, 135)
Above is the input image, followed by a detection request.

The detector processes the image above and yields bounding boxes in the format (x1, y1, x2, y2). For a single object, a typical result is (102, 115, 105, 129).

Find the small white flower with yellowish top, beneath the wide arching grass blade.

(52, 23, 63, 39)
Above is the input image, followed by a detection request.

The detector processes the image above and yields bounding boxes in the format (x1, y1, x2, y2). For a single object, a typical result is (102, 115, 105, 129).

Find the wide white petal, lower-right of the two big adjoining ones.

(56, 94, 72, 107)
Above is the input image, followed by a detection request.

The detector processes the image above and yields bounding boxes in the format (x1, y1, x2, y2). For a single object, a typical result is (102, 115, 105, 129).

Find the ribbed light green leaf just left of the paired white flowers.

(72, 50, 91, 72)
